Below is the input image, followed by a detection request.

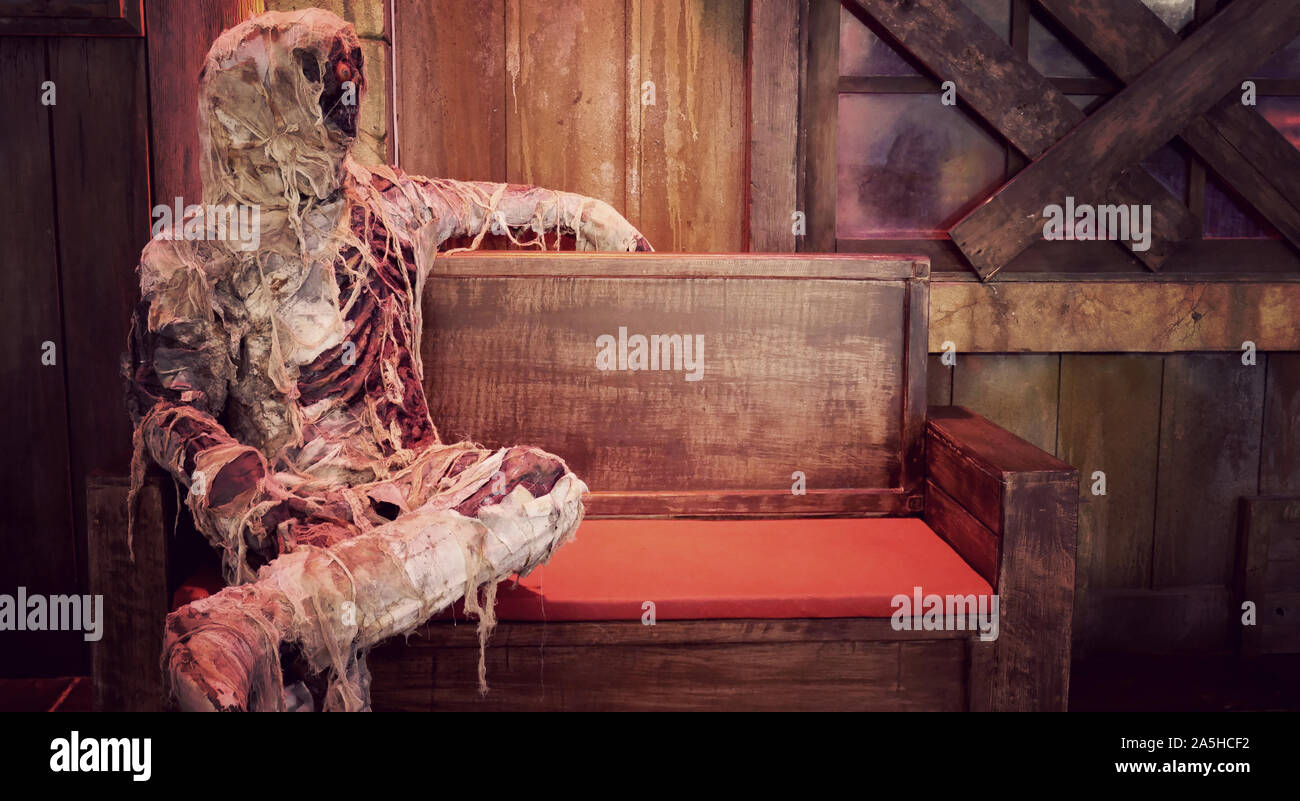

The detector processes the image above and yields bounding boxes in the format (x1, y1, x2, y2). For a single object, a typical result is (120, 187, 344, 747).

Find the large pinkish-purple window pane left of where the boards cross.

(836, 94, 1006, 238)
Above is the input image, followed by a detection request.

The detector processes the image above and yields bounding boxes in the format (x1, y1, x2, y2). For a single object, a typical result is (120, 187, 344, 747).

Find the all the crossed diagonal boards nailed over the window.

(845, 0, 1300, 280)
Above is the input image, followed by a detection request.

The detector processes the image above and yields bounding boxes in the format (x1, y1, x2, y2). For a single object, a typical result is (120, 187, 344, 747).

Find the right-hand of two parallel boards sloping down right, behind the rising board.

(1039, 0, 1300, 246)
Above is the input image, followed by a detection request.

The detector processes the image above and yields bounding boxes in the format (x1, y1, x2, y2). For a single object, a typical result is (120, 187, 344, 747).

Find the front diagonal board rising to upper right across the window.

(950, 0, 1300, 278)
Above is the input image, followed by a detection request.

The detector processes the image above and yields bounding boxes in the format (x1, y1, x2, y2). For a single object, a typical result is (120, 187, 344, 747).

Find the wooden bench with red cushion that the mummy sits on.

(88, 251, 1078, 710)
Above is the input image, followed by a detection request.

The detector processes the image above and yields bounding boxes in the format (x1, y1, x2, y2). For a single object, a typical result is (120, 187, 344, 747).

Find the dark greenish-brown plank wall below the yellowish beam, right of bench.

(930, 352, 1300, 657)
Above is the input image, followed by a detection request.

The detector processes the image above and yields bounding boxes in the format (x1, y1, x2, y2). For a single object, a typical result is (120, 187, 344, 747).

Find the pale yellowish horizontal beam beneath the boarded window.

(930, 277, 1300, 351)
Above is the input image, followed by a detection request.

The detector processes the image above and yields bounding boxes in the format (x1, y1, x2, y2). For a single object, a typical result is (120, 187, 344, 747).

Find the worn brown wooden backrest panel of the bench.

(423, 262, 924, 514)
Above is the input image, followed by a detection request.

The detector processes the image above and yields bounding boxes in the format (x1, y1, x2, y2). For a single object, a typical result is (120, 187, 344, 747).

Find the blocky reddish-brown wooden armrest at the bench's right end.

(924, 406, 1079, 710)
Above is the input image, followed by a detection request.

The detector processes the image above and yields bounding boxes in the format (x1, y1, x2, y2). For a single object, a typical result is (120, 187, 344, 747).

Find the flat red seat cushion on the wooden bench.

(497, 518, 993, 620)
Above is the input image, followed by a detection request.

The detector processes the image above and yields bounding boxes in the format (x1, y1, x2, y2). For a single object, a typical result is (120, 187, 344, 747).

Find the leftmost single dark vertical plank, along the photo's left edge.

(0, 39, 86, 676)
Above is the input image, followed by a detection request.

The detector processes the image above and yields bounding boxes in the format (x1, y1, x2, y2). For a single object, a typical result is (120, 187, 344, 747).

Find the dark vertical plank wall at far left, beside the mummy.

(0, 36, 150, 675)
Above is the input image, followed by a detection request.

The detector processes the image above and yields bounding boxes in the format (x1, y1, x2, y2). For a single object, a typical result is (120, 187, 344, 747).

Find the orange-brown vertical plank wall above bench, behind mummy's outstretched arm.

(394, 0, 748, 252)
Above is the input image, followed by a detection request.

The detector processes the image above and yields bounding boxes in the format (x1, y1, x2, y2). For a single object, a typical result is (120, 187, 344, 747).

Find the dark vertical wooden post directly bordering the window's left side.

(797, 0, 840, 252)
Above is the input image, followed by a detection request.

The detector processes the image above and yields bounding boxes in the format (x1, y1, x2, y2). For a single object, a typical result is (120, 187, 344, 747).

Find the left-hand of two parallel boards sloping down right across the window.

(848, 0, 1197, 274)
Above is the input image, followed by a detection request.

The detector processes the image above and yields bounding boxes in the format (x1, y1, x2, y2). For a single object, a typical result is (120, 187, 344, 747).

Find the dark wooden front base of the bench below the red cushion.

(369, 619, 989, 711)
